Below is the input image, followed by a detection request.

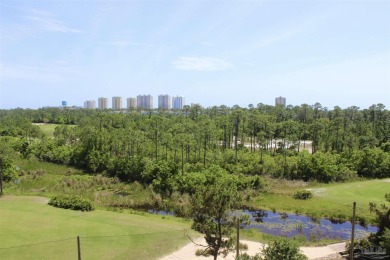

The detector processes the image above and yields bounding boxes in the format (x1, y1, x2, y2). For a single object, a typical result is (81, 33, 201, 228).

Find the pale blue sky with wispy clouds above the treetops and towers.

(0, 0, 390, 109)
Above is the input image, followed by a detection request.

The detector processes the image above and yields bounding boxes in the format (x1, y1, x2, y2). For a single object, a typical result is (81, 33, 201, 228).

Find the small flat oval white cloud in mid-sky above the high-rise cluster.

(172, 57, 233, 71)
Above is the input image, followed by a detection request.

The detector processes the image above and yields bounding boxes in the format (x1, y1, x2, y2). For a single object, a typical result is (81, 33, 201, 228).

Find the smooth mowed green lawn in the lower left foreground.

(0, 196, 195, 259)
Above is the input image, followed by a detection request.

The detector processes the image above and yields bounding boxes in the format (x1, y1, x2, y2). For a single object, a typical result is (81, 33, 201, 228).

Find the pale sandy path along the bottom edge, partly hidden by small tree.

(160, 238, 345, 260)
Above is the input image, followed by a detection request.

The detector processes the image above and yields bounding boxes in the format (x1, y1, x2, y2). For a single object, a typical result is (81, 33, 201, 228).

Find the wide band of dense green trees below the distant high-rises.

(0, 103, 390, 186)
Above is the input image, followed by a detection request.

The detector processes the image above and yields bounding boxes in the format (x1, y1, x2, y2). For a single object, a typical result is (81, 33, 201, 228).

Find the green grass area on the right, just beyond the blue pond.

(250, 179, 390, 221)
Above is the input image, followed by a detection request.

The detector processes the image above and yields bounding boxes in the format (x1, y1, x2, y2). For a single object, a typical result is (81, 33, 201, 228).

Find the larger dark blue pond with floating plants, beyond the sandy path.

(244, 210, 377, 241)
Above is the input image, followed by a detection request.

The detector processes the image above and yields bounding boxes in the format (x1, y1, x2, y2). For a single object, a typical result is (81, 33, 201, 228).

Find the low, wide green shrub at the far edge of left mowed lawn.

(49, 195, 95, 211)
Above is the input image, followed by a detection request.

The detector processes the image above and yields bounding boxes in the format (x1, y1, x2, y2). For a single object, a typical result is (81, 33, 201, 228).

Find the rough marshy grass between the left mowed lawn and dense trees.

(4, 156, 157, 209)
